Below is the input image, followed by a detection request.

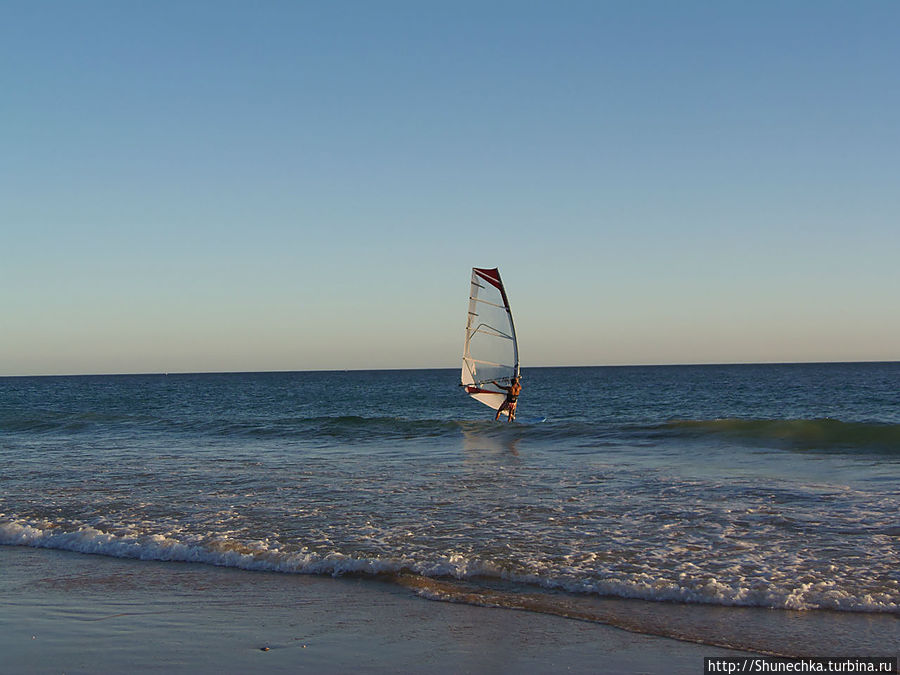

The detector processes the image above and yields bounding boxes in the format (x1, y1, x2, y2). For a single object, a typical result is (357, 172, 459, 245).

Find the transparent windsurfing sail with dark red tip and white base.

(461, 267, 519, 410)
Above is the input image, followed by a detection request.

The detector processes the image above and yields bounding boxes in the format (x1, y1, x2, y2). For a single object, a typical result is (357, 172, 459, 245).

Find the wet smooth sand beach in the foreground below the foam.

(0, 546, 744, 673)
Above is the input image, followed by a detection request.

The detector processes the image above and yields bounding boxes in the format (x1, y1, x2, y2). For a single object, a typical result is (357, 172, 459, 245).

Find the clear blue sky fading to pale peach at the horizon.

(0, 0, 900, 375)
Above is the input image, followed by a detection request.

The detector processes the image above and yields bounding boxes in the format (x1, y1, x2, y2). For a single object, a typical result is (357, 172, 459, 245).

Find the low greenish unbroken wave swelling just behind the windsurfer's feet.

(0, 411, 900, 454)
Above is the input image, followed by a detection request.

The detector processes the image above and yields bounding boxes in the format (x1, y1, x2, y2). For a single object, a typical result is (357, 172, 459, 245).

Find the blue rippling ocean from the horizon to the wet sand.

(0, 363, 900, 656)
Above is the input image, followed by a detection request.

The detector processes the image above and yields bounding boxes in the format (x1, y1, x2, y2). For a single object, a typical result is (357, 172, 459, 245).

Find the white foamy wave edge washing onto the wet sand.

(0, 520, 900, 613)
